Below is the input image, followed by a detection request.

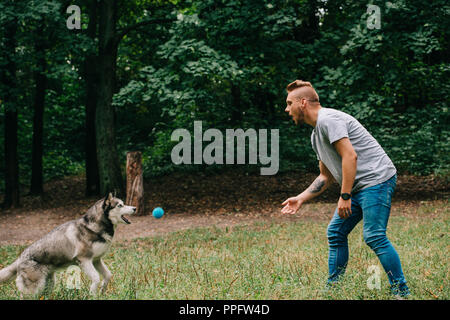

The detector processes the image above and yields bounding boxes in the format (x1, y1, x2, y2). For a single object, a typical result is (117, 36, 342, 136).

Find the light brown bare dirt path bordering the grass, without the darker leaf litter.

(0, 204, 333, 246)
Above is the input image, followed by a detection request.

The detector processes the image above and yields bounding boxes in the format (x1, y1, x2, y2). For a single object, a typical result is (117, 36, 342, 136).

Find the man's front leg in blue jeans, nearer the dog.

(327, 199, 362, 285)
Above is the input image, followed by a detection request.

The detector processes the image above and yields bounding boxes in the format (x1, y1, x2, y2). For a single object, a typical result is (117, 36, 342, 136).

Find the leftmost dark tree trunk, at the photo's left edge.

(0, 20, 20, 209)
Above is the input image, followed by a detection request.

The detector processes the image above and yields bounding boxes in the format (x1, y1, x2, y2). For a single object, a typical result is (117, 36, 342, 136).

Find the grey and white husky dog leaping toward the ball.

(0, 193, 136, 295)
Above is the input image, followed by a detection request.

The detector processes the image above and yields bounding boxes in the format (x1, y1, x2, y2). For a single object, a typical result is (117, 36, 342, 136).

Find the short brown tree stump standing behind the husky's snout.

(125, 151, 145, 215)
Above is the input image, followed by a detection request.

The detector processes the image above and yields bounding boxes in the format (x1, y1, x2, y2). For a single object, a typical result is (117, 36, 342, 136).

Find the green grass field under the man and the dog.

(0, 201, 450, 300)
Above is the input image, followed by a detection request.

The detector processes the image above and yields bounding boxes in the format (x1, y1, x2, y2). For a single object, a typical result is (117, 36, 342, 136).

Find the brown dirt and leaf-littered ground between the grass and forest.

(0, 173, 449, 245)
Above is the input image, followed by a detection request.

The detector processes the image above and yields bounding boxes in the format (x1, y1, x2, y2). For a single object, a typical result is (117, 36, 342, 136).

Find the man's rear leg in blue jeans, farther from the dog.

(361, 177, 409, 296)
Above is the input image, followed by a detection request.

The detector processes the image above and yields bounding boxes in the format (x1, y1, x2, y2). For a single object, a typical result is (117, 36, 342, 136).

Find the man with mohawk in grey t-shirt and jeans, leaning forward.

(281, 80, 409, 297)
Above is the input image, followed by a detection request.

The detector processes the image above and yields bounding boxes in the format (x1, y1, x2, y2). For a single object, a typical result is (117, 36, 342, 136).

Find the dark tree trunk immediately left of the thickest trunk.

(84, 1, 100, 196)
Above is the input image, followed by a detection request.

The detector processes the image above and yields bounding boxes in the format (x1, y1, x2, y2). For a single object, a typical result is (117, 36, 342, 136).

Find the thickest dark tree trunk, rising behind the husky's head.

(95, 0, 124, 196)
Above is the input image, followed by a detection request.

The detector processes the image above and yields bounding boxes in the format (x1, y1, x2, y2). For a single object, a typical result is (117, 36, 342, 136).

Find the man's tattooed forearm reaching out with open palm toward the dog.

(281, 161, 334, 214)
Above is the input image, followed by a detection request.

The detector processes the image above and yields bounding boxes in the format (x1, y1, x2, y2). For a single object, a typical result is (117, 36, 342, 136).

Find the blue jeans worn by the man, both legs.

(327, 175, 409, 296)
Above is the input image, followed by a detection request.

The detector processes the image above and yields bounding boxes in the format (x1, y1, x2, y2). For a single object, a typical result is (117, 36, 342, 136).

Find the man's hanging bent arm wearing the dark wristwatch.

(333, 138, 358, 218)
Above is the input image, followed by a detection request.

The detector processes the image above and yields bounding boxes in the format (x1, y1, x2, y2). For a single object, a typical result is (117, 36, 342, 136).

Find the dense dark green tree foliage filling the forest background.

(0, 0, 450, 189)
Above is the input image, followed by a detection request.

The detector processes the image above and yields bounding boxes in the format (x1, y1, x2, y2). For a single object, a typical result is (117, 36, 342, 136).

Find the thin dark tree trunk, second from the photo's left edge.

(30, 37, 47, 195)
